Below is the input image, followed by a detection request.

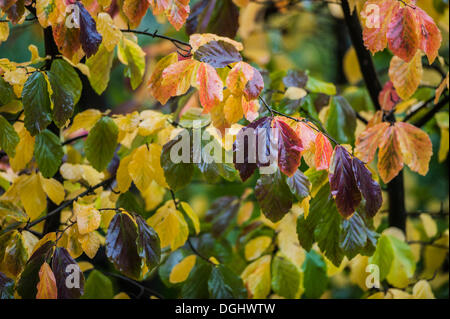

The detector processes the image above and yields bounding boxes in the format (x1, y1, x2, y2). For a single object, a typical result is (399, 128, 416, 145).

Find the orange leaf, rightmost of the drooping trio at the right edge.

(395, 122, 433, 175)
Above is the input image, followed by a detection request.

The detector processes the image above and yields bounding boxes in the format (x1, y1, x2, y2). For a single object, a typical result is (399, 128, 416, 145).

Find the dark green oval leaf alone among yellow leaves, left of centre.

(85, 116, 119, 172)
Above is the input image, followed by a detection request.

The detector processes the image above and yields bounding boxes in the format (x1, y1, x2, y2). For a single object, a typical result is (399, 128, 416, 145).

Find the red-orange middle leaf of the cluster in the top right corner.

(387, 7, 420, 62)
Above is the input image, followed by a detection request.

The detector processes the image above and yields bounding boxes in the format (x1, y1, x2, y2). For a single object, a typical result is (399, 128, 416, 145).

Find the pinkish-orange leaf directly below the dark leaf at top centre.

(197, 63, 223, 113)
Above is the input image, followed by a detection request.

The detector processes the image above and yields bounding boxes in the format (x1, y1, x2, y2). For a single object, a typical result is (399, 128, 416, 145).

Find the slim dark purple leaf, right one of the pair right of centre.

(352, 157, 383, 217)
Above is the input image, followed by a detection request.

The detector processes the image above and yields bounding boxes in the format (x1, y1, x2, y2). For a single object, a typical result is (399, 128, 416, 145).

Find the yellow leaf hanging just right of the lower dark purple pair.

(147, 200, 189, 250)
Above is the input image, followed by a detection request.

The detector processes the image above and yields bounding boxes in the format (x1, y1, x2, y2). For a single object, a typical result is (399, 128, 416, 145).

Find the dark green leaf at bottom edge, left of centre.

(181, 258, 212, 299)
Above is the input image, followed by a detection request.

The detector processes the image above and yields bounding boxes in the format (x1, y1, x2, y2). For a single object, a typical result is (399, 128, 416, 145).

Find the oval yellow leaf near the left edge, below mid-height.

(19, 173, 47, 219)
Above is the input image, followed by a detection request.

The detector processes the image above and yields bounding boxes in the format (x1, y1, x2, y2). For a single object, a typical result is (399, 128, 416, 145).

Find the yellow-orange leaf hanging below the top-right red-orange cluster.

(389, 51, 423, 100)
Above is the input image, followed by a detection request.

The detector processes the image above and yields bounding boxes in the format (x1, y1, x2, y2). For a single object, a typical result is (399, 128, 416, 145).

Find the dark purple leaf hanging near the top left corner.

(76, 1, 102, 58)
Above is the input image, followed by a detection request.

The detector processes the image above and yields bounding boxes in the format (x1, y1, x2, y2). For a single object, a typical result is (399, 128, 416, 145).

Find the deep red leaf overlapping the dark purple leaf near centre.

(273, 117, 303, 176)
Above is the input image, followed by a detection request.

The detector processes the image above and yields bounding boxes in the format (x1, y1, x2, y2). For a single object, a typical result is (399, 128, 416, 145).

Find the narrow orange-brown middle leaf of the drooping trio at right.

(375, 124, 403, 183)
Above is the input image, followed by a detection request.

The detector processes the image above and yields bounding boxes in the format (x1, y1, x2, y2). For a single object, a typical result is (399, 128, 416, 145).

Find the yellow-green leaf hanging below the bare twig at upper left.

(118, 38, 145, 90)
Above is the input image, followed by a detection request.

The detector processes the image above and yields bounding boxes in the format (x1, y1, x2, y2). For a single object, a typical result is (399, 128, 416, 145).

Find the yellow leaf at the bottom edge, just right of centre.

(241, 255, 272, 299)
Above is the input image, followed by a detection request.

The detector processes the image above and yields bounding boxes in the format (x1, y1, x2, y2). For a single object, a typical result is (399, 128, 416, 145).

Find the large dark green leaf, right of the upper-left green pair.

(48, 59, 82, 127)
